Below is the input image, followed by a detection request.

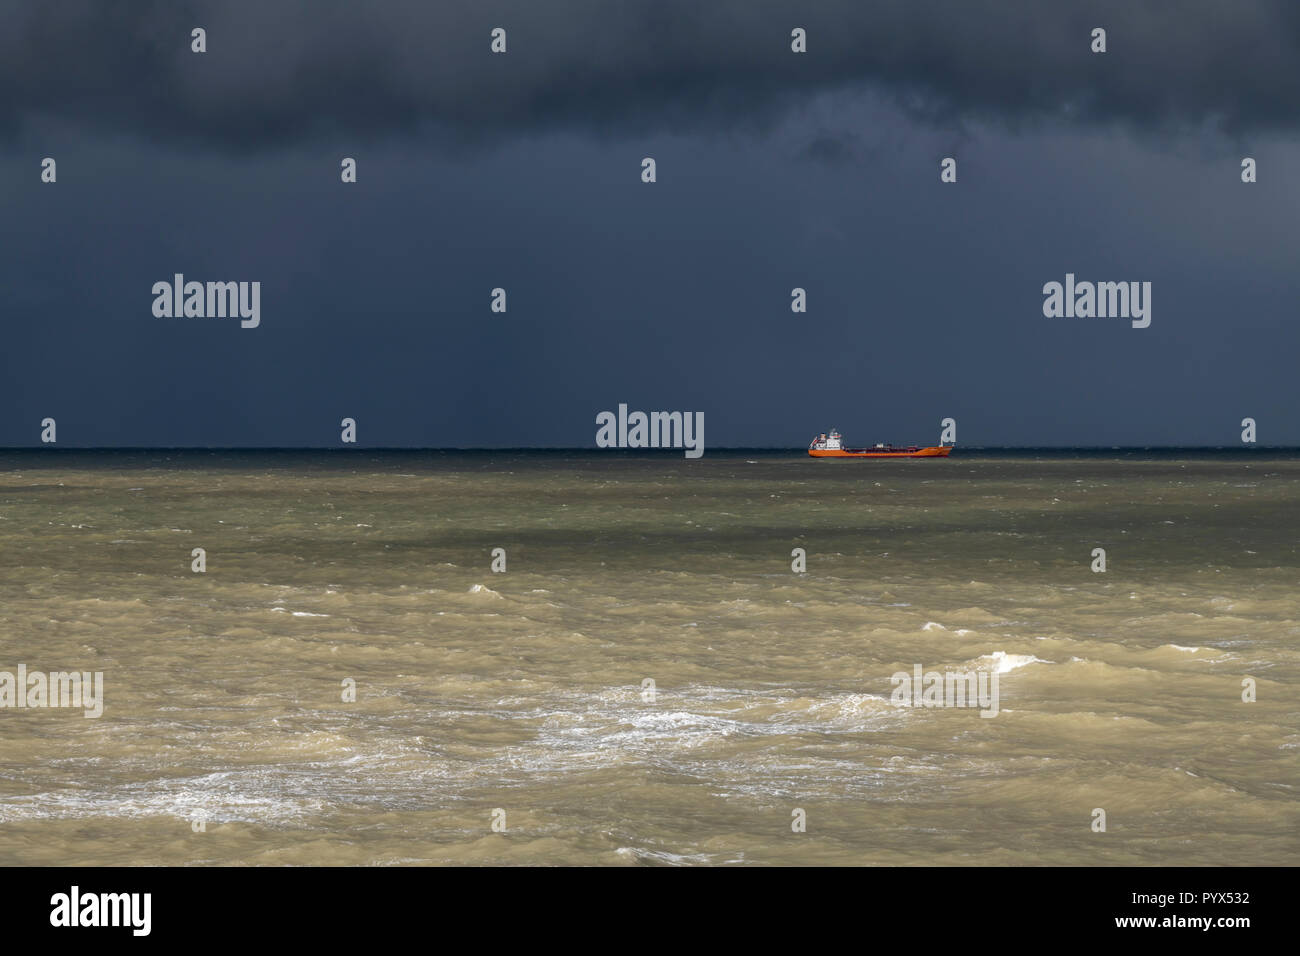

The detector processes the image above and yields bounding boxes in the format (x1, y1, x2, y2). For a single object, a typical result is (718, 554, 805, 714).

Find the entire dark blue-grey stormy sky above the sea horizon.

(0, 0, 1300, 447)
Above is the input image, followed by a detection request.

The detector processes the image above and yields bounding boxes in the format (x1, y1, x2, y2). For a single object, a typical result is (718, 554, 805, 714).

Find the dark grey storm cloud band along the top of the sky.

(0, 0, 1300, 153)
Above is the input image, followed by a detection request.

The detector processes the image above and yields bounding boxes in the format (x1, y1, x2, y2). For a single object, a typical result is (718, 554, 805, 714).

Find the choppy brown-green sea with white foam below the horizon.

(0, 451, 1300, 865)
